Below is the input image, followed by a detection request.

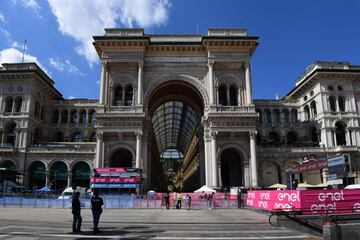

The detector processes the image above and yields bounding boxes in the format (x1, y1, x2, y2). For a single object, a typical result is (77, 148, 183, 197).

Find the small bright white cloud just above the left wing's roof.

(0, 48, 50, 75)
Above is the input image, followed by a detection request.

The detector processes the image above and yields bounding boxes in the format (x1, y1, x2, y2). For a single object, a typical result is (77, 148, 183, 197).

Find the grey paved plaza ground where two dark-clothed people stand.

(0, 208, 319, 240)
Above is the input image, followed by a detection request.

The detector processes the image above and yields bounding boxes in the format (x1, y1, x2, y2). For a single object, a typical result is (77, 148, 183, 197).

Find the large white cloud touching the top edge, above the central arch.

(48, 0, 170, 65)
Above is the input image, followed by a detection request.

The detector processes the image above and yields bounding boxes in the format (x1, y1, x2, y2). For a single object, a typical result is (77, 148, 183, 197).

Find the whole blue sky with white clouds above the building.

(0, 0, 360, 99)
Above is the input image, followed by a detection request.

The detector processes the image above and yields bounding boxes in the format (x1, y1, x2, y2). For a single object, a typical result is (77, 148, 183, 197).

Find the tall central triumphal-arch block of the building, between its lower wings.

(94, 29, 258, 191)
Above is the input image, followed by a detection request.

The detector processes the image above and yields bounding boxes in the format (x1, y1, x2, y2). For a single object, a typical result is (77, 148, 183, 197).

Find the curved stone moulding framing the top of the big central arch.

(144, 74, 209, 109)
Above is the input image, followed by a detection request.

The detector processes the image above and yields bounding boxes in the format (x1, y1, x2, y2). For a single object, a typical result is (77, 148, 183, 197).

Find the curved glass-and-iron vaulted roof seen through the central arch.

(151, 101, 198, 155)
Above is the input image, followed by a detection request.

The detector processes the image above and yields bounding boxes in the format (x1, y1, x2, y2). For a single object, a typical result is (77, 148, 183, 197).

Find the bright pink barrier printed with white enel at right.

(246, 190, 360, 214)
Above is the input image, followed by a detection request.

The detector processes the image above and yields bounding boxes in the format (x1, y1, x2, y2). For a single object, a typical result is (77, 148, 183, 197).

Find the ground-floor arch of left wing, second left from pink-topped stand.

(50, 162, 68, 190)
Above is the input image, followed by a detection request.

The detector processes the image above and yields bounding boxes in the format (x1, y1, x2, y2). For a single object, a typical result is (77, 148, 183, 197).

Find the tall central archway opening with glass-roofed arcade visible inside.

(148, 80, 205, 191)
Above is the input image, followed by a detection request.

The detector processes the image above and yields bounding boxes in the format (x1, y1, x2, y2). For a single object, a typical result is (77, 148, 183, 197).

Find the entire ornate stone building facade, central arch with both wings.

(0, 29, 360, 191)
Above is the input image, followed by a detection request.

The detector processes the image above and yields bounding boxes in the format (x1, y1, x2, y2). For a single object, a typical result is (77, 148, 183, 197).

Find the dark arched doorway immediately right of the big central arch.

(220, 148, 243, 188)
